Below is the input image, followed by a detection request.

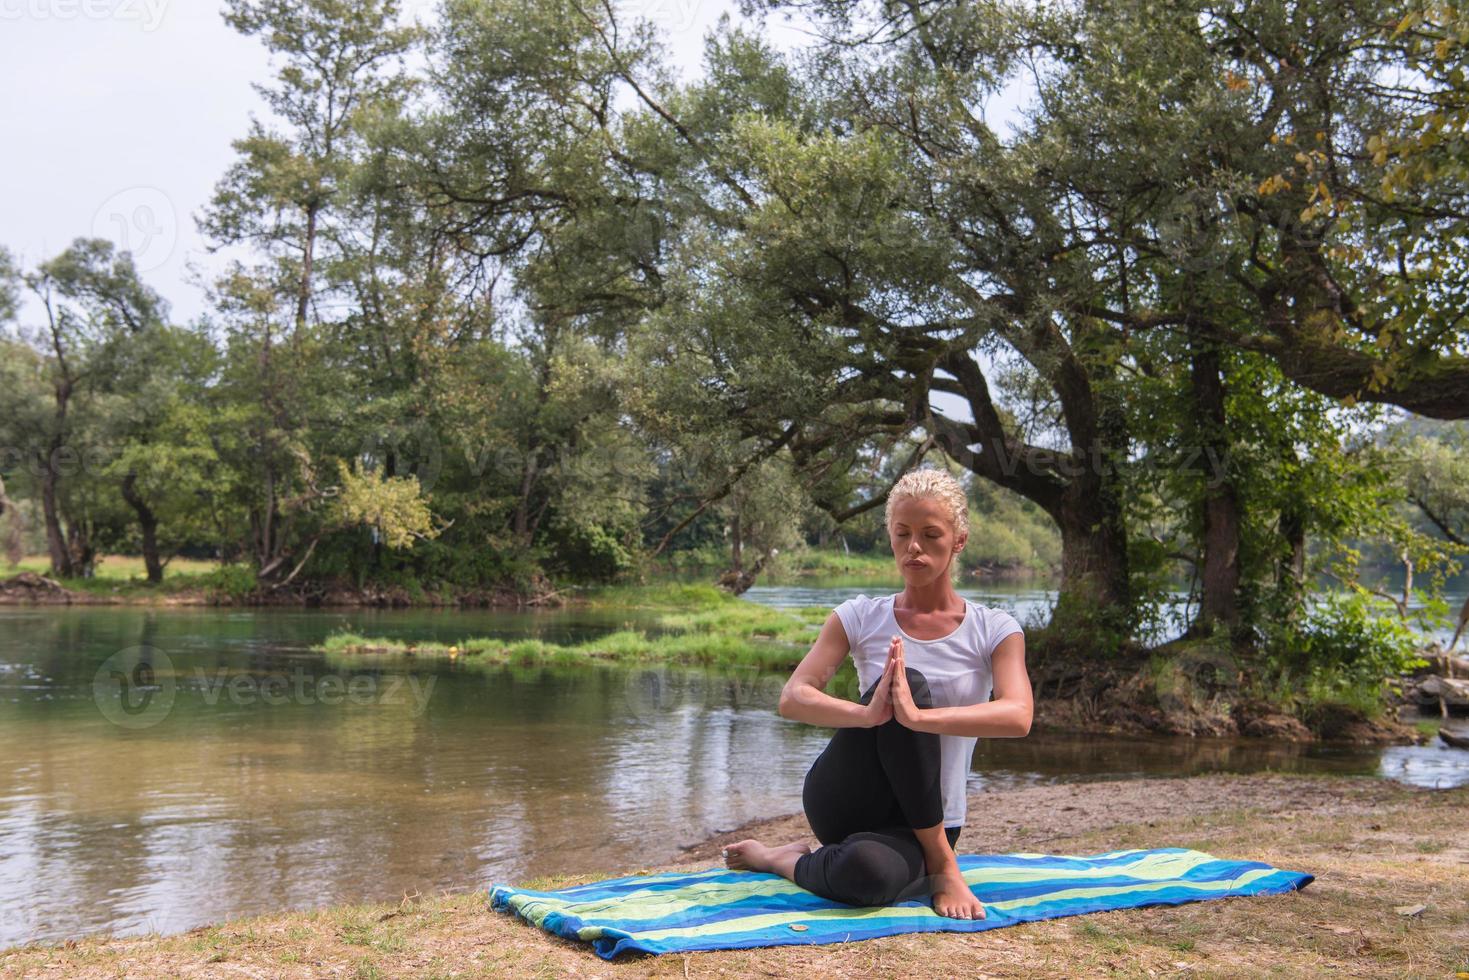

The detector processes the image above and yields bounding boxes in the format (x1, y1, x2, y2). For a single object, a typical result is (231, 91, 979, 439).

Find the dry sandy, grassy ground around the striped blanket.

(0, 773, 1469, 979)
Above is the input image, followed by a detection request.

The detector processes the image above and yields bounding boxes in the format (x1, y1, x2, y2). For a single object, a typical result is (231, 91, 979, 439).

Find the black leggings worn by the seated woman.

(795, 667, 959, 907)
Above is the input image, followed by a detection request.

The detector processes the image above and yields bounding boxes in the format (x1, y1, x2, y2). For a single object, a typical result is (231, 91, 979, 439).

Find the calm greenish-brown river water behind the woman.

(0, 582, 1469, 945)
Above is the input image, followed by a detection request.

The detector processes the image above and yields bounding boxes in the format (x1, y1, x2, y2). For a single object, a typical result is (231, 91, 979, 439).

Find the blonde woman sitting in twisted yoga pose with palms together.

(724, 469, 1033, 918)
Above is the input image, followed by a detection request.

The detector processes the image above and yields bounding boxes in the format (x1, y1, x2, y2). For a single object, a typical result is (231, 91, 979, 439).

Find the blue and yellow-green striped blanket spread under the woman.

(489, 848, 1315, 959)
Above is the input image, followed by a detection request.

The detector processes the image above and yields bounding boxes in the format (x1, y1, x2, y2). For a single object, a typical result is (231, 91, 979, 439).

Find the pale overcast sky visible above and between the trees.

(0, 0, 998, 417)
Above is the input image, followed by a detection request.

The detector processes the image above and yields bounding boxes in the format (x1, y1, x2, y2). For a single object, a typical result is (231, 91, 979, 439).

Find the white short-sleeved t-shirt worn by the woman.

(836, 594, 1024, 827)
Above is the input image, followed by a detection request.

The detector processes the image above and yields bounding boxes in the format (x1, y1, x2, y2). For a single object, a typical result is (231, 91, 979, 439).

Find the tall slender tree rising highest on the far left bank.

(200, 0, 419, 585)
